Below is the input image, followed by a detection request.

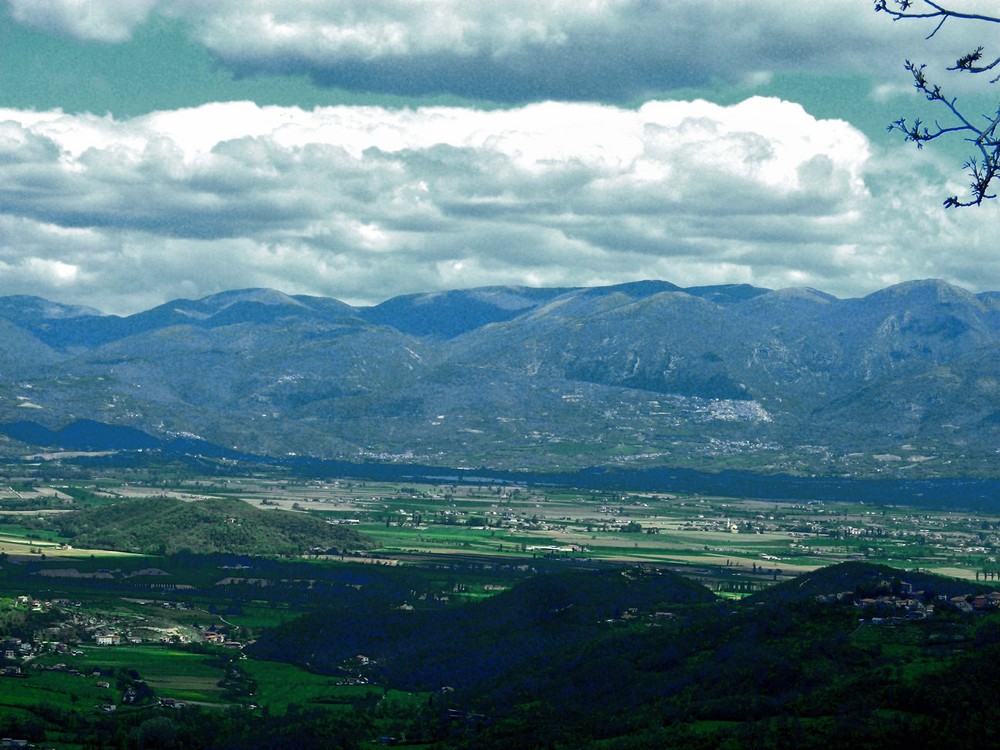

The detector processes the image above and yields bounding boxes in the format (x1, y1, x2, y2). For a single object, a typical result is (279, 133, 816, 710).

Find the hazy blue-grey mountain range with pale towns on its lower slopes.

(0, 281, 1000, 476)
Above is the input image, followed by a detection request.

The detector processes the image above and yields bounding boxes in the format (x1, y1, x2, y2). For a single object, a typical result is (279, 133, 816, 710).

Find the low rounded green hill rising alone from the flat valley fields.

(43, 497, 371, 556)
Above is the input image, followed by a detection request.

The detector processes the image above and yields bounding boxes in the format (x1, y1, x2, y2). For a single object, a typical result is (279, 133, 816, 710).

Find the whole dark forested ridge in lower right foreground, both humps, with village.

(244, 563, 1000, 748)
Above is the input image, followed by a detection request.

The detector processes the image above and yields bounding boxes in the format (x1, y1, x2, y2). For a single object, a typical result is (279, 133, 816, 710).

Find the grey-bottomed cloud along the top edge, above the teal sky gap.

(7, 0, 926, 102)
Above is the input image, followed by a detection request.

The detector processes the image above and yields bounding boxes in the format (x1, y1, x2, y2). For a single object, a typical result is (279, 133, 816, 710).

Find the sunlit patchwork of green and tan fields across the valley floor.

(0, 468, 1000, 588)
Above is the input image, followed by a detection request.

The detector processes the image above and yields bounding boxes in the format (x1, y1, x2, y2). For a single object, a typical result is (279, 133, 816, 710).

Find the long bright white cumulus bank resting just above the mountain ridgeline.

(0, 98, 1000, 312)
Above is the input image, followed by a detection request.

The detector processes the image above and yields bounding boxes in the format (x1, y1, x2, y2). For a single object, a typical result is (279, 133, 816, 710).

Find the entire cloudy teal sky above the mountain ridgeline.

(0, 0, 1000, 314)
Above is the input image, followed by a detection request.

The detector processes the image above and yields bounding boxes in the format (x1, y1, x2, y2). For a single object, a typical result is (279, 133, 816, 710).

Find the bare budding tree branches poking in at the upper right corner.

(875, 0, 1000, 208)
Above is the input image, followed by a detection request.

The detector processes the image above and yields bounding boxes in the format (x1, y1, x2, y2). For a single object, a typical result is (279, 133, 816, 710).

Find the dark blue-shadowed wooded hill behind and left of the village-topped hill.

(251, 569, 715, 690)
